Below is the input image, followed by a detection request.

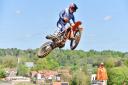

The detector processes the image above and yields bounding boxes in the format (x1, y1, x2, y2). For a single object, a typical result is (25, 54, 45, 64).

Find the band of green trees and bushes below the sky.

(0, 48, 128, 85)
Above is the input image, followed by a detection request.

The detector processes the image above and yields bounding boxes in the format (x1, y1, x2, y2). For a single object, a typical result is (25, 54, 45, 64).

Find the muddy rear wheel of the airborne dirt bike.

(37, 41, 53, 58)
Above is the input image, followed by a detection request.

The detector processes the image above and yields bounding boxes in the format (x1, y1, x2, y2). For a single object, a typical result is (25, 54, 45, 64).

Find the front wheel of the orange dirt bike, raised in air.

(70, 30, 81, 50)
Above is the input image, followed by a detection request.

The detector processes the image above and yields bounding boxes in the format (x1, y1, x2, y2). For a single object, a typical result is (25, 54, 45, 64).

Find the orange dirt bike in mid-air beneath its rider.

(37, 21, 83, 58)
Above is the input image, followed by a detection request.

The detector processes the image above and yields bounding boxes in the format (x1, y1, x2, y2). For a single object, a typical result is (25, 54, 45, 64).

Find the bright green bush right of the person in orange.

(108, 66, 128, 85)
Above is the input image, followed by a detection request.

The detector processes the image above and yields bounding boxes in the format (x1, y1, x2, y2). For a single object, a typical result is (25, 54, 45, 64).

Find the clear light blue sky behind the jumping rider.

(0, 0, 128, 52)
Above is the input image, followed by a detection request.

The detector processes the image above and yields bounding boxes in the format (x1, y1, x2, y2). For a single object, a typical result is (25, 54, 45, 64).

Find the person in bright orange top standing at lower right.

(96, 63, 108, 85)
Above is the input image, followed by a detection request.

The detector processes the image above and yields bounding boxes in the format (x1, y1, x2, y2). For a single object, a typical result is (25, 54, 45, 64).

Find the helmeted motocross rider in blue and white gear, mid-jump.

(46, 3, 78, 39)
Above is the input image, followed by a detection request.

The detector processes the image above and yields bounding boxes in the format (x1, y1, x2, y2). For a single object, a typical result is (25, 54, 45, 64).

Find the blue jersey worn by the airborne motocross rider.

(57, 8, 75, 26)
